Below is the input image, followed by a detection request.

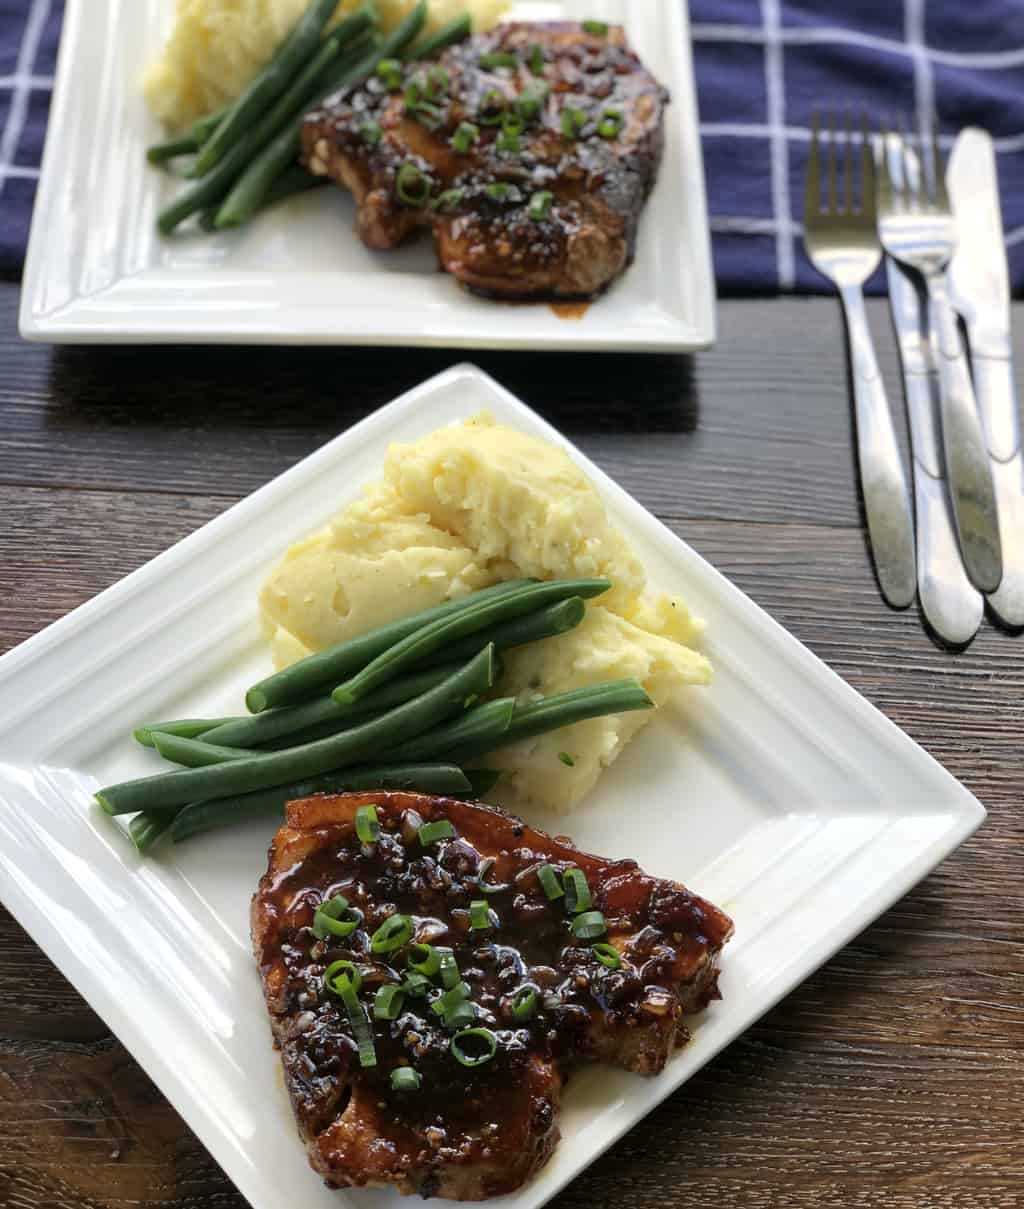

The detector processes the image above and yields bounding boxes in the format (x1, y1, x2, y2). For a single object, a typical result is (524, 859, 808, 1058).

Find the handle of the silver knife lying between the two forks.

(903, 374, 985, 647)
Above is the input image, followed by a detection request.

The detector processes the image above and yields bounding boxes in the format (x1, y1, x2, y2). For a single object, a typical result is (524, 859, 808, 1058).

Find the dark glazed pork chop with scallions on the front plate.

(251, 792, 733, 1201)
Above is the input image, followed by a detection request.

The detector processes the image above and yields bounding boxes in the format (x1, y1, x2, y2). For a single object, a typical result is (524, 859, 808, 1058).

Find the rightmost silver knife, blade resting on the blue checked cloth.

(947, 128, 1024, 626)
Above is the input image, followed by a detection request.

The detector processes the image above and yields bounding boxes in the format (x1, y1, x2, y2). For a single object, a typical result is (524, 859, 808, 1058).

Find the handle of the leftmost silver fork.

(839, 285, 918, 608)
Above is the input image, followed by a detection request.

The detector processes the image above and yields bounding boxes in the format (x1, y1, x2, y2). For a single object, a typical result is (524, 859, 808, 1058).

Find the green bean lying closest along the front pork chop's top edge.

(170, 764, 470, 844)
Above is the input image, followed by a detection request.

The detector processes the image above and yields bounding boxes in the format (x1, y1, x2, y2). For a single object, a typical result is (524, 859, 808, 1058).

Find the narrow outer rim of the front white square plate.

(0, 363, 985, 1204)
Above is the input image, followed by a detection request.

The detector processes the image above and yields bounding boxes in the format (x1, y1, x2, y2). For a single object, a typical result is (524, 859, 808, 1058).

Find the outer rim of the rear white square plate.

(18, 0, 718, 353)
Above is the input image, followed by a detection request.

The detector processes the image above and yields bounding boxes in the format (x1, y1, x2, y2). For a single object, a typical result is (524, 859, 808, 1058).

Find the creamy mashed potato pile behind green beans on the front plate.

(260, 413, 711, 810)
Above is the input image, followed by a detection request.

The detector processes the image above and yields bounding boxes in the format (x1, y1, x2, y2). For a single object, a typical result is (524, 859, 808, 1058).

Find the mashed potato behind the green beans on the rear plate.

(144, 0, 508, 129)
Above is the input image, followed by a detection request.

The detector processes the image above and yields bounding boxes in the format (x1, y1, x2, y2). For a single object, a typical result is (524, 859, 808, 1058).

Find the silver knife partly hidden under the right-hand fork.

(883, 135, 984, 647)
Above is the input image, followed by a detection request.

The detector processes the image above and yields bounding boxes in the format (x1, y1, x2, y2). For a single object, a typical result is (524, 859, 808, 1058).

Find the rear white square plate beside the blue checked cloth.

(21, 0, 715, 351)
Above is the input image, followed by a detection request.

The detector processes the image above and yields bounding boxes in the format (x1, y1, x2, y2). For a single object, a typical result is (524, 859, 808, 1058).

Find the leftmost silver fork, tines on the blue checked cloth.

(804, 115, 916, 608)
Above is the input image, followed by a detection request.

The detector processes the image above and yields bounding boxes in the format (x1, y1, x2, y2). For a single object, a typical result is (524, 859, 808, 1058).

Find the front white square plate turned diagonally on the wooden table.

(0, 368, 984, 1209)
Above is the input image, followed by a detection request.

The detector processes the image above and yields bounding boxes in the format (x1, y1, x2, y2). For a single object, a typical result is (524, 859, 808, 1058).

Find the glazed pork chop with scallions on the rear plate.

(302, 22, 667, 299)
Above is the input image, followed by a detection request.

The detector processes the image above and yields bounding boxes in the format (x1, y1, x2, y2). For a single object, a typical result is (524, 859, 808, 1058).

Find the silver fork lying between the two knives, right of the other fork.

(878, 128, 1002, 592)
